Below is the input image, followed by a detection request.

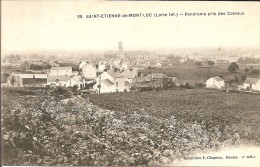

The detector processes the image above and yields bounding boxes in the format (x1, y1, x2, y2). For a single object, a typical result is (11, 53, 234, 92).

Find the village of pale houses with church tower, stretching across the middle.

(1, 41, 260, 94)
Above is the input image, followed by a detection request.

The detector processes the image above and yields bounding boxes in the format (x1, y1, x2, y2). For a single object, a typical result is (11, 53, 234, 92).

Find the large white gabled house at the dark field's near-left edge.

(93, 69, 131, 93)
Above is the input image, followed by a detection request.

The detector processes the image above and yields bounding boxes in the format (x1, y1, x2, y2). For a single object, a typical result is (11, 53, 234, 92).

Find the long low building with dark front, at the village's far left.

(7, 73, 47, 87)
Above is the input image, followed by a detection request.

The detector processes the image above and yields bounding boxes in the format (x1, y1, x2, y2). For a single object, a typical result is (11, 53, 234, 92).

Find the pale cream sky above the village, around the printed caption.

(1, 0, 260, 53)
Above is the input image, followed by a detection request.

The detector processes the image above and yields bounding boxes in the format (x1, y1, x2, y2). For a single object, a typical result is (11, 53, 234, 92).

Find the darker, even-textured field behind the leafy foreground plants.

(91, 89, 260, 144)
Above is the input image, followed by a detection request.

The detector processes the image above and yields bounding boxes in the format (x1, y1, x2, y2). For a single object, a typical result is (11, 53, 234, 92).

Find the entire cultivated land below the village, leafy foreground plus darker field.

(1, 89, 260, 166)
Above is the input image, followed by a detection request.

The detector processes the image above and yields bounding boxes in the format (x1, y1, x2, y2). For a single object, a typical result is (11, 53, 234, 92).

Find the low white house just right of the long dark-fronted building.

(47, 75, 70, 87)
